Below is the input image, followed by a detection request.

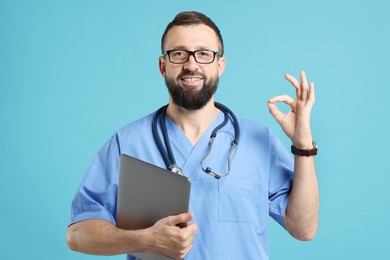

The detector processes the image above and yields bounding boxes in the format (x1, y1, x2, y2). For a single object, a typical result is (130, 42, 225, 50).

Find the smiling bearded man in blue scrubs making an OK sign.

(67, 12, 319, 259)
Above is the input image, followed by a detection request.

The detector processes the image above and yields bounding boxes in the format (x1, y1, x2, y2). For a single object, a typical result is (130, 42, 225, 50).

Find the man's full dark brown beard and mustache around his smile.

(165, 71, 219, 110)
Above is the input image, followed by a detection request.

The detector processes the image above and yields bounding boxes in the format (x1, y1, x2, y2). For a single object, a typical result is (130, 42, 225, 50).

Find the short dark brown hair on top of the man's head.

(161, 11, 224, 53)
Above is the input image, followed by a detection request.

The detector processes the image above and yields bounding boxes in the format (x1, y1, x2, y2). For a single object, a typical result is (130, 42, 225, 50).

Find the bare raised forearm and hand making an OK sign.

(268, 71, 319, 240)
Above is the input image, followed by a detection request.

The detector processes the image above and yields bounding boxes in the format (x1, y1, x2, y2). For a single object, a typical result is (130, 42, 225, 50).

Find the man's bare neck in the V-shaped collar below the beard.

(167, 98, 219, 145)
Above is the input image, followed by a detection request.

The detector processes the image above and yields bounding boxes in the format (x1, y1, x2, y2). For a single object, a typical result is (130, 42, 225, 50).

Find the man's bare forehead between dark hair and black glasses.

(165, 24, 218, 50)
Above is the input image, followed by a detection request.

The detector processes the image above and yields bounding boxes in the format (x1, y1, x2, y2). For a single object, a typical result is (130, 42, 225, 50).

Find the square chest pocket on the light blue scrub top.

(218, 180, 262, 223)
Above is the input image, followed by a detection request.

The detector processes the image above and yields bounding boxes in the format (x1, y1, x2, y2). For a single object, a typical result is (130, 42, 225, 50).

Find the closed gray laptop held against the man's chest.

(116, 155, 191, 260)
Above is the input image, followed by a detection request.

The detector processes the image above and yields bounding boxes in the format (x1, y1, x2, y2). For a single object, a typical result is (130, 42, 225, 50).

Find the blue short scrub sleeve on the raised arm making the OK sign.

(268, 134, 294, 227)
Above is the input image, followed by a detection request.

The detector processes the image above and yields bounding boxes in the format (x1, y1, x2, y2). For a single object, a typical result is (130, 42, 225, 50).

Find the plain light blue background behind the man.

(0, 0, 390, 260)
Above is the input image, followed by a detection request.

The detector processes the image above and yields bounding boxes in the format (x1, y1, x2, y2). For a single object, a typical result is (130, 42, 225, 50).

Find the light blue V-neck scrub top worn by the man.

(70, 110, 293, 259)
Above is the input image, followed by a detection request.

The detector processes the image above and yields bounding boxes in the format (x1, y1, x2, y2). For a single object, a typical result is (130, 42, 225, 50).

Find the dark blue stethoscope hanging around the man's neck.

(152, 102, 240, 179)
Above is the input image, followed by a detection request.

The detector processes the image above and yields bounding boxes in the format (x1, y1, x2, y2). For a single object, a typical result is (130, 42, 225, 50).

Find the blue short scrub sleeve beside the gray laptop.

(70, 136, 120, 224)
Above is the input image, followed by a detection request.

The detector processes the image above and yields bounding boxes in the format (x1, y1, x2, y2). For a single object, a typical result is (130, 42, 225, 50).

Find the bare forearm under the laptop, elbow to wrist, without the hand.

(66, 220, 145, 255)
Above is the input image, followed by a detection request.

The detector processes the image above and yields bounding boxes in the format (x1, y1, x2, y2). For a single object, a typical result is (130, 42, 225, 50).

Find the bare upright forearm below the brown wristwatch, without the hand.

(285, 156, 319, 240)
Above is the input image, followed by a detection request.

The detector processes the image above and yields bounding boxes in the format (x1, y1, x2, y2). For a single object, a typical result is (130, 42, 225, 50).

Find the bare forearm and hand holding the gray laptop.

(66, 213, 197, 259)
